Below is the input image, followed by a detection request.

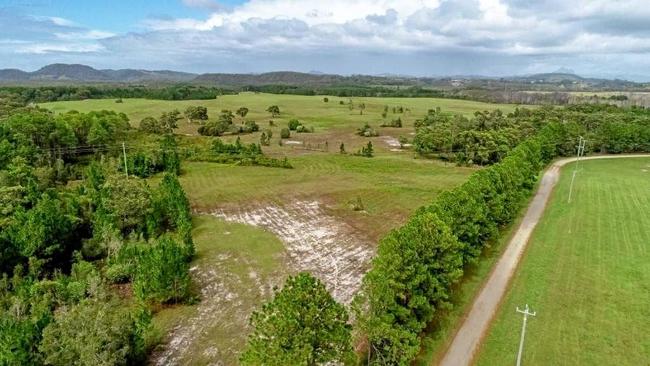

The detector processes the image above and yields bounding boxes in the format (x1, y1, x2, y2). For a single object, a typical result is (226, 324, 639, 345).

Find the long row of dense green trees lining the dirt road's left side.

(357, 124, 559, 364)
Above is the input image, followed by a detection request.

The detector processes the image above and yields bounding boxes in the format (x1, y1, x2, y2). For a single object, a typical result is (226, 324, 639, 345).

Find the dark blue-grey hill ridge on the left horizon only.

(0, 64, 196, 83)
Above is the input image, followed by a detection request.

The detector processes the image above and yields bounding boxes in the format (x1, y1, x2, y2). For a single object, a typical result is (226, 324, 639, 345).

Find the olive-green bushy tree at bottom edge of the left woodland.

(39, 299, 144, 366)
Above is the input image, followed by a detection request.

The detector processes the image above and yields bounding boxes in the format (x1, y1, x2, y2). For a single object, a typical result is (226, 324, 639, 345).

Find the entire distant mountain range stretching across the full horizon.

(0, 64, 648, 90)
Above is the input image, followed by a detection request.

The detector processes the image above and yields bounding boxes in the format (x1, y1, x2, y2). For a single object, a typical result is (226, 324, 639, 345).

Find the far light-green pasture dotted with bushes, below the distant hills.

(40, 93, 516, 156)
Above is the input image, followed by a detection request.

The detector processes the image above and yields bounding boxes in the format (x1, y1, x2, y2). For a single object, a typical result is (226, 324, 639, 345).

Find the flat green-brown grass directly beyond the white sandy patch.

(180, 153, 475, 240)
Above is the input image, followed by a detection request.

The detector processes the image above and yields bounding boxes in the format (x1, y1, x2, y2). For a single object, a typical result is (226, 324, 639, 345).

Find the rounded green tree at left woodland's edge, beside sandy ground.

(133, 236, 190, 303)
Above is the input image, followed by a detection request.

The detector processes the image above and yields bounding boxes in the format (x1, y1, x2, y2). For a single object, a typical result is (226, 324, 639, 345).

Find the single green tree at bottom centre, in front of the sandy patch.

(241, 273, 354, 366)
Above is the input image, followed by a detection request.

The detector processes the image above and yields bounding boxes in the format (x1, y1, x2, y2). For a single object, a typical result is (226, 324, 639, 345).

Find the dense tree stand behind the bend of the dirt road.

(413, 104, 650, 165)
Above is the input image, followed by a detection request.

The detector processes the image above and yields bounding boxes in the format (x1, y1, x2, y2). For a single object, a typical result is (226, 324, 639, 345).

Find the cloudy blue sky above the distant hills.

(0, 0, 650, 81)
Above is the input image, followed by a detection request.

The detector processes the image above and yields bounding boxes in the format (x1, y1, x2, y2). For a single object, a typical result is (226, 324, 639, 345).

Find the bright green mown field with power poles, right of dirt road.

(478, 158, 650, 365)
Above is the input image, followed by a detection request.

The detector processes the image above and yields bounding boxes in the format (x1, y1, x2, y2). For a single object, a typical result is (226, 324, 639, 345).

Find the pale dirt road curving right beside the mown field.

(440, 155, 650, 366)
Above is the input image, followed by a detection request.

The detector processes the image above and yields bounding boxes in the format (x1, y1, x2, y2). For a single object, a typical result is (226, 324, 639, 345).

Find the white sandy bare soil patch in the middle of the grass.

(213, 201, 374, 303)
